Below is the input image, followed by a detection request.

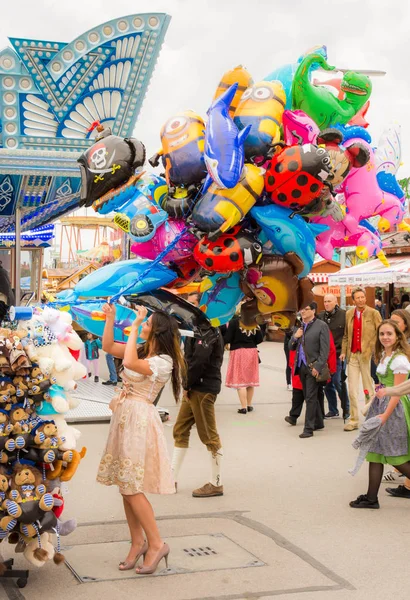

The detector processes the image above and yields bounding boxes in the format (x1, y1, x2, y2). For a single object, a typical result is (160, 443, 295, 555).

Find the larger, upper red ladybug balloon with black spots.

(265, 144, 331, 212)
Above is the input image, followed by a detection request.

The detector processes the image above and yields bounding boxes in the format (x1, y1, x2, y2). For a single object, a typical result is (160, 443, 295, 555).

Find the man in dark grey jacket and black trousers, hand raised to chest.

(289, 302, 330, 438)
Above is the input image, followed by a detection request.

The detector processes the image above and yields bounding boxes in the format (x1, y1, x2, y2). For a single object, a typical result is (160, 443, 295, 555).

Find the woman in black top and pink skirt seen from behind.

(224, 317, 263, 415)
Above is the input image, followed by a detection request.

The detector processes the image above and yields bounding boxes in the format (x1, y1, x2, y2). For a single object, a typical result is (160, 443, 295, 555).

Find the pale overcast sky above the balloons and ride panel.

(0, 0, 410, 258)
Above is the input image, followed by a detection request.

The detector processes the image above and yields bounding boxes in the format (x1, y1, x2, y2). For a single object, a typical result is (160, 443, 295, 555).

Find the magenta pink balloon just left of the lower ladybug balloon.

(131, 219, 198, 262)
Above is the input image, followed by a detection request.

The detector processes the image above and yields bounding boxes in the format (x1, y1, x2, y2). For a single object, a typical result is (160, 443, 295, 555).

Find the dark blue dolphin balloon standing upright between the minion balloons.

(203, 83, 251, 193)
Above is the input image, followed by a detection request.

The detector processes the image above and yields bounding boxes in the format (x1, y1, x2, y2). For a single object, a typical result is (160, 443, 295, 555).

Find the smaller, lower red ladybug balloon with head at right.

(194, 225, 262, 273)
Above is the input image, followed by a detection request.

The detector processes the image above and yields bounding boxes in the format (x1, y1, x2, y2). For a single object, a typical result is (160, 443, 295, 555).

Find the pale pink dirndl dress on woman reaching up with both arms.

(97, 354, 175, 495)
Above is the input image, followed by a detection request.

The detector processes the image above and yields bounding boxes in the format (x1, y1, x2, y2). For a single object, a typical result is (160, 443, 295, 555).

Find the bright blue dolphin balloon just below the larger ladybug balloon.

(250, 204, 329, 278)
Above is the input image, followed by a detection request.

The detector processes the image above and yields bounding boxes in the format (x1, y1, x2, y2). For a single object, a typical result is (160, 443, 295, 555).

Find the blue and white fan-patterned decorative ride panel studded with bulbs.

(0, 13, 170, 152)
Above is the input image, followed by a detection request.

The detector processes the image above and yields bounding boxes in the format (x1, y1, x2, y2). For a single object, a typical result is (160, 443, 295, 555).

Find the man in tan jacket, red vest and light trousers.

(340, 287, 382, 431)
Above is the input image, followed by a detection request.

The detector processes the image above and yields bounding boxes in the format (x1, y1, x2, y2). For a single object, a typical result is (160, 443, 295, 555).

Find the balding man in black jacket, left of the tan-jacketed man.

(318, 294, 349, 419)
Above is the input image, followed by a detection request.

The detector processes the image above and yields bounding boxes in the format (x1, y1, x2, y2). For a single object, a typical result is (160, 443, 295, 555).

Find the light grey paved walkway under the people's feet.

(0, 343, 410, 600)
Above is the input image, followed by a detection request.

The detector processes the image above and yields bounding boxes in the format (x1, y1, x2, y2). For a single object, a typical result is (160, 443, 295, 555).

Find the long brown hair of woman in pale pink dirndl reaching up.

(138, 310, 186, 402)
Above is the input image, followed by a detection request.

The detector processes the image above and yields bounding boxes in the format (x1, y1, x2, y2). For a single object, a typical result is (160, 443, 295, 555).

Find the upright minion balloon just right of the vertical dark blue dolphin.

(234, 81, 286, 160)
